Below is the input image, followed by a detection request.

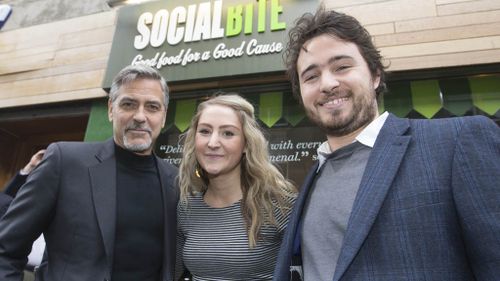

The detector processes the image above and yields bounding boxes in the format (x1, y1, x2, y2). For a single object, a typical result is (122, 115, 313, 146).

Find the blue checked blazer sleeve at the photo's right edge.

(452, 116, 500, 280)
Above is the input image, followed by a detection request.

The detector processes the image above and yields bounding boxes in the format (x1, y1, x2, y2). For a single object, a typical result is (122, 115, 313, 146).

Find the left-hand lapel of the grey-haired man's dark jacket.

(89, 140, 116, 268)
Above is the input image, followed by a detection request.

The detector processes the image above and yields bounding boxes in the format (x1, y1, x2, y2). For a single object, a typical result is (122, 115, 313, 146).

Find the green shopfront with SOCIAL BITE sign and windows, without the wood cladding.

(78, 0, 500, 184)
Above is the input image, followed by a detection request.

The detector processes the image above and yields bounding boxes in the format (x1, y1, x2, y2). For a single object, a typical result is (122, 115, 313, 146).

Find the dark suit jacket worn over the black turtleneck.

(0, 140, 178, 281)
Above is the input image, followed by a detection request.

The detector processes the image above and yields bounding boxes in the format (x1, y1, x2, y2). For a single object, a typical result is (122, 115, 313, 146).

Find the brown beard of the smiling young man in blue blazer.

(305, 87, 378, 137)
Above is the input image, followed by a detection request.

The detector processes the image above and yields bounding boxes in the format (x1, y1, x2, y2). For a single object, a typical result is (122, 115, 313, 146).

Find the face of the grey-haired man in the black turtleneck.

(108, 79, 167, 155)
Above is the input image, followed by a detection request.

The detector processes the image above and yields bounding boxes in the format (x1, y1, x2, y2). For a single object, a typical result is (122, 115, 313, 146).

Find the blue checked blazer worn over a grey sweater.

(274, 115, 500, 281)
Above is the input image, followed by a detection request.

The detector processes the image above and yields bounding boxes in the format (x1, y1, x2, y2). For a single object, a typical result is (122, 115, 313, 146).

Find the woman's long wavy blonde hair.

(179, 93, 297, 248)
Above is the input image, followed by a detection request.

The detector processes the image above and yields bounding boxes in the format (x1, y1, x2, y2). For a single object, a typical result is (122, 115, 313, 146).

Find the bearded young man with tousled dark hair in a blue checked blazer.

(274, 8, 500, 281)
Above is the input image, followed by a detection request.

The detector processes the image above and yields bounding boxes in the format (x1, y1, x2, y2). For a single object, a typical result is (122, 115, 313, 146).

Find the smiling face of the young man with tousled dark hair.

(297, 34, 380, 137)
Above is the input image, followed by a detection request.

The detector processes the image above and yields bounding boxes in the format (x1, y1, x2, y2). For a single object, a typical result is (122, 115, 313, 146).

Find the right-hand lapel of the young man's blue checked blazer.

(333, 114, 411, 281)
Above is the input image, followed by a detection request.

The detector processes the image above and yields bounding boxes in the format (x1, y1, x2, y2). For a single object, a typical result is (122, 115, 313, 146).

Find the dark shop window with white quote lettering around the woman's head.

(156, 87, 326, 185)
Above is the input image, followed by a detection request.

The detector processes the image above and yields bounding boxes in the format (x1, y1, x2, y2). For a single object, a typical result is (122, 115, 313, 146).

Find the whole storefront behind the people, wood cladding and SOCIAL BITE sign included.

(0, 0, 500, 188)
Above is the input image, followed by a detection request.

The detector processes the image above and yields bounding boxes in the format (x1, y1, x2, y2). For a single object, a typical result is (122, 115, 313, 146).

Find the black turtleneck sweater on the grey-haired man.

(111, 145, 164, 281)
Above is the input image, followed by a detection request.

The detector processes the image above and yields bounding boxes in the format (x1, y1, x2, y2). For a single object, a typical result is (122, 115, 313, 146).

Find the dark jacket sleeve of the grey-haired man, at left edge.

(0, 144, 62, 281)
